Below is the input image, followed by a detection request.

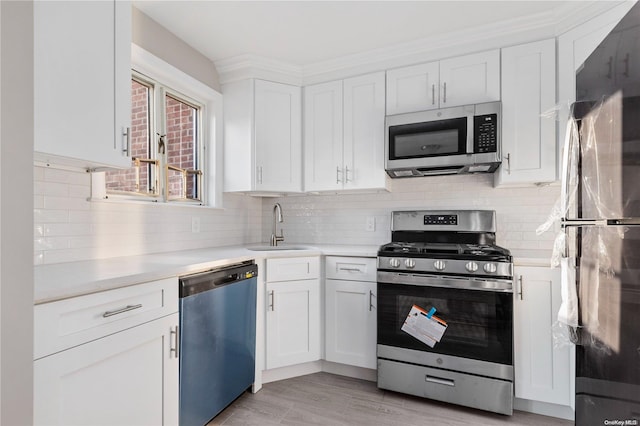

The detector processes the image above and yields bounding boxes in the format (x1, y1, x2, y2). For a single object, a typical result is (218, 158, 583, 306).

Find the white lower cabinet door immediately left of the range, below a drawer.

(325, 280, 377, 368)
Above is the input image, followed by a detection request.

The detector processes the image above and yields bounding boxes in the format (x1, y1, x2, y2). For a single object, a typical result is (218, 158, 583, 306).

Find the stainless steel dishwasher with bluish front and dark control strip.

(180, 261, 258, 426)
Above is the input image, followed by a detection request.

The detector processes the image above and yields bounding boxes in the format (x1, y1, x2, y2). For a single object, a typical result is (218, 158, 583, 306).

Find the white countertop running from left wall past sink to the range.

(34, 244, 378, 304)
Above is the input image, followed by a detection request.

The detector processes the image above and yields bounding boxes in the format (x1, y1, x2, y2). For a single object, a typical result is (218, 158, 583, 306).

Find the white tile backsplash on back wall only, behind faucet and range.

(262, 174, 560, 251)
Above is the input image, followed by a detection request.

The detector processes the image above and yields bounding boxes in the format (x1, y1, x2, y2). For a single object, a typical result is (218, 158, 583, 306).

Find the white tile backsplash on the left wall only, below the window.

(33, 167, 262, 265)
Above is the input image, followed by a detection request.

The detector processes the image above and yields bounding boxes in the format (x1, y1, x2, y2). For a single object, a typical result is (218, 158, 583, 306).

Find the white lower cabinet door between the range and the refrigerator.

(513, 267, 572, 406)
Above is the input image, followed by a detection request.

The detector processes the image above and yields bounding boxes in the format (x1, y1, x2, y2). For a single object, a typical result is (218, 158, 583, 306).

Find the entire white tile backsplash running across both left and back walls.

(34, 166, 560, 264)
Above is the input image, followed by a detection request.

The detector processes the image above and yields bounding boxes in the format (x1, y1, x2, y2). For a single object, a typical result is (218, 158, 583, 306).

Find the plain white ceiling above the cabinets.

(134, 0, 593, 66)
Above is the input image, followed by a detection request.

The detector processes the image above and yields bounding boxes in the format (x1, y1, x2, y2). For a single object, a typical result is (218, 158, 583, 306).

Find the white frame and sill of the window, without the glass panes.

(92, 43, 223, 208)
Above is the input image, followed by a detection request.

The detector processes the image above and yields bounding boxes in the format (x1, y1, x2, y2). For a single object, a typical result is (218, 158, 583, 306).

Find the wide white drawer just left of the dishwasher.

(34, 278, 178, 359)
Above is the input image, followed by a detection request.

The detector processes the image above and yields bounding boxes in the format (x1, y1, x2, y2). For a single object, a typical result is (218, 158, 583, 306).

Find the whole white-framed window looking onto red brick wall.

(92, 45, 222, 207)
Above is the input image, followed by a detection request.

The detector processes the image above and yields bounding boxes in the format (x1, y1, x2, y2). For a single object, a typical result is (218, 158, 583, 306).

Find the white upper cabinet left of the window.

(33, 0, 131, 168)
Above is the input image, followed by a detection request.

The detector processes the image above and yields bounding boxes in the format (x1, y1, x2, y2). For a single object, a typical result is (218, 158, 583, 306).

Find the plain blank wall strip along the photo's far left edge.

(0, 1, 33, 425)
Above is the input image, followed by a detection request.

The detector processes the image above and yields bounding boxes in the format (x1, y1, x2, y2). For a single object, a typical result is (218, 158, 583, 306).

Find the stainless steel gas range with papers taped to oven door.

(377, 210, 513, 415)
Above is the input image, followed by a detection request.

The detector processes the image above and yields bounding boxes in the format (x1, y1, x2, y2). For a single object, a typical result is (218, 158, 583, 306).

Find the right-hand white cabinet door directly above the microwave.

(440, 50, 500, 108)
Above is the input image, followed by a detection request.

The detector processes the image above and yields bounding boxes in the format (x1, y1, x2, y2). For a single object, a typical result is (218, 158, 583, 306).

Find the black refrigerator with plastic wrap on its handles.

(559, 4, 640, 426)
